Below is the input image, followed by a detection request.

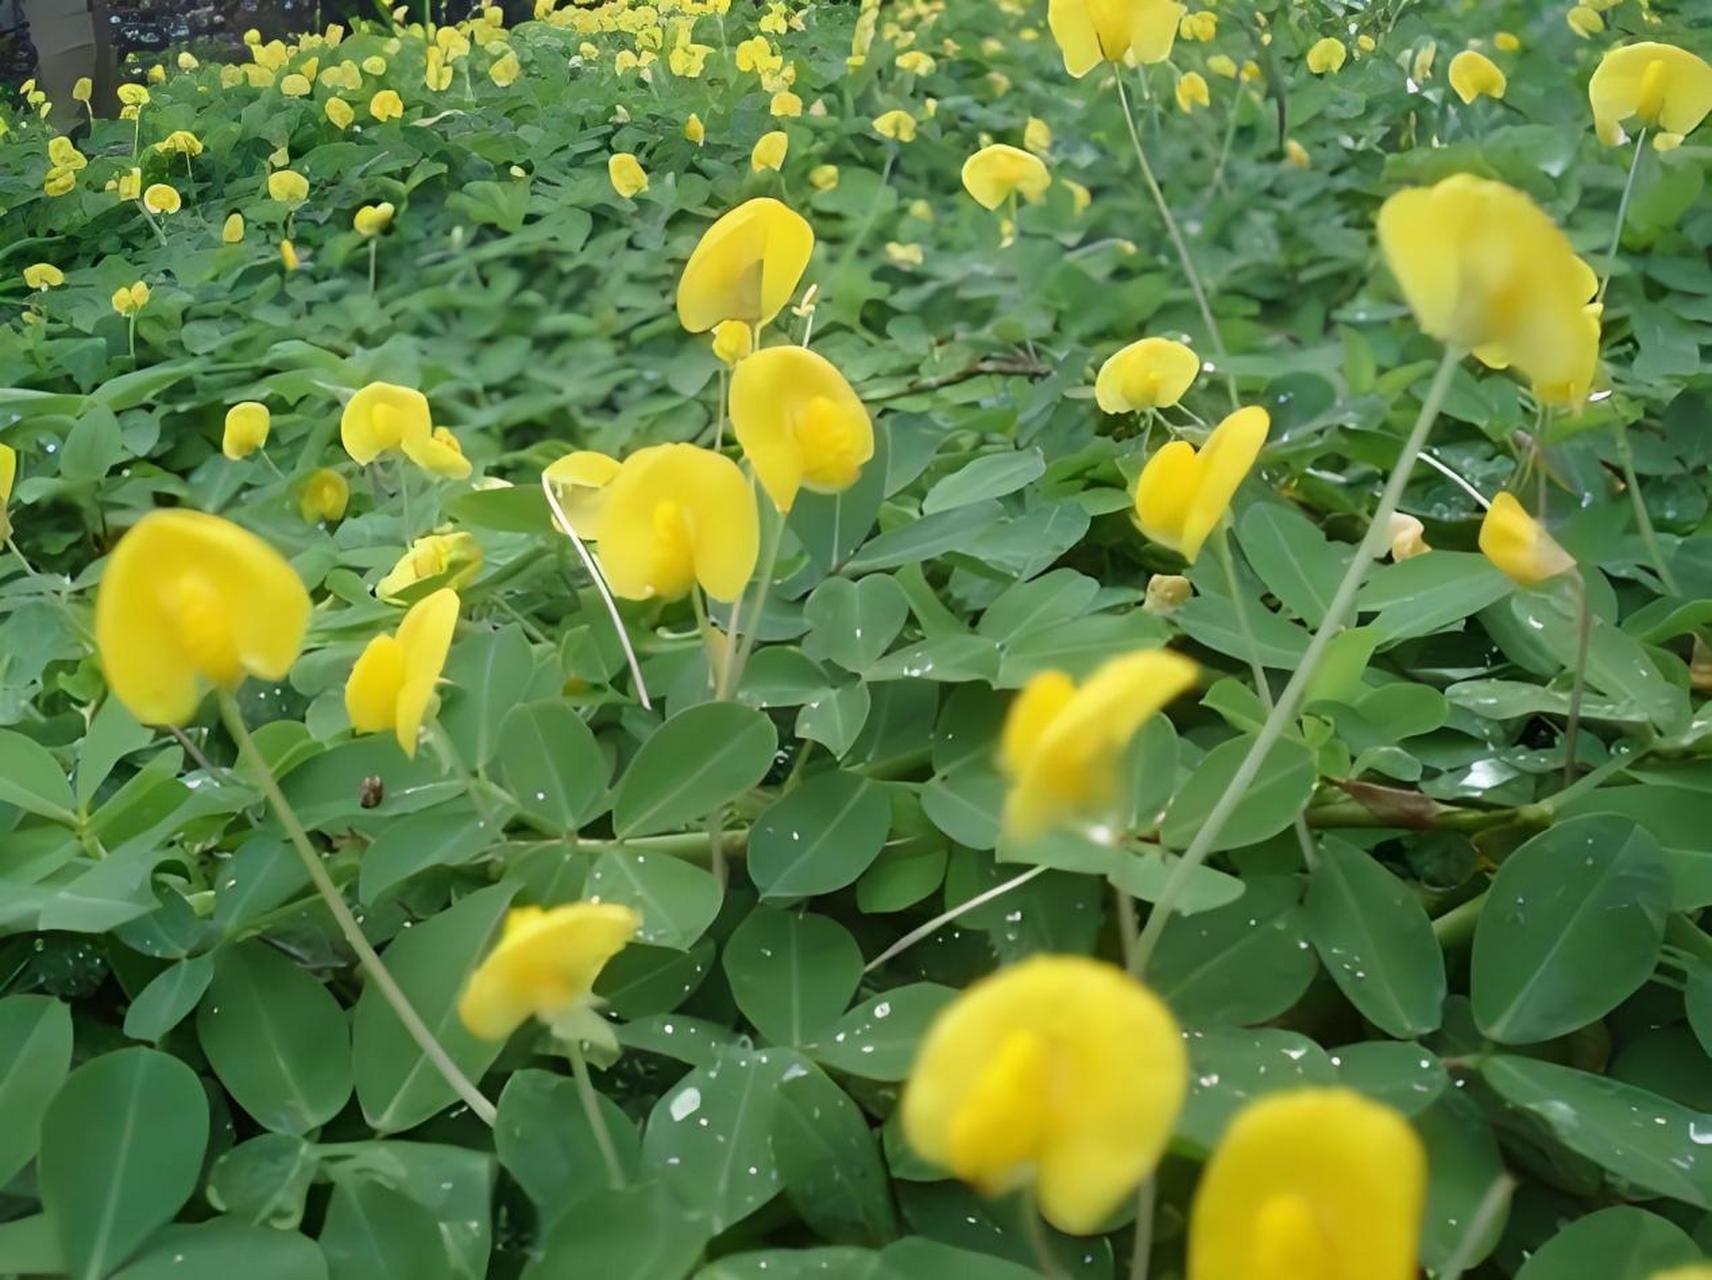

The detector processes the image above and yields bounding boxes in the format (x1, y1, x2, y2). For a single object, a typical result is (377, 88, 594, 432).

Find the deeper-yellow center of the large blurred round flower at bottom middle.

(948, 1030, 1051, 1194)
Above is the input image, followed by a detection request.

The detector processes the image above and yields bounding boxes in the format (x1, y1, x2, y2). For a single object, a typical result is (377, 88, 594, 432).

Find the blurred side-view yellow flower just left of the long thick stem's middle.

(1000, 649, 1195, 840)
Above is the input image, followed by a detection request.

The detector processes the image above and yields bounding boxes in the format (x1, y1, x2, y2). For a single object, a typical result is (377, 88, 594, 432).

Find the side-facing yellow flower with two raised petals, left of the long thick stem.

(1135, 406, 1272, 565)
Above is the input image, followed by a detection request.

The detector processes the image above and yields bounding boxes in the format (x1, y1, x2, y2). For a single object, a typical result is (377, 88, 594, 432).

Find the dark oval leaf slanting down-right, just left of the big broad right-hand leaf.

(1308, 840, 1445, 1040)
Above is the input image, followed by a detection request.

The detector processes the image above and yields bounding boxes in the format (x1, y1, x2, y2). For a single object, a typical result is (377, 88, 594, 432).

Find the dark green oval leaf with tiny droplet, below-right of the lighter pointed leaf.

(748, 770, 892, 900)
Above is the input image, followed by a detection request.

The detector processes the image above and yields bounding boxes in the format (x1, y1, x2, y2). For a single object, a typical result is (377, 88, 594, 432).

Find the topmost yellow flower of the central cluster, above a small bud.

(678, 195, 815, 334)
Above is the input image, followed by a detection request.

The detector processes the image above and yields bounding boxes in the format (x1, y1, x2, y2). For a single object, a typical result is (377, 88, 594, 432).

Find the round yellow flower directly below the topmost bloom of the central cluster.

(731, 347, 873, 512)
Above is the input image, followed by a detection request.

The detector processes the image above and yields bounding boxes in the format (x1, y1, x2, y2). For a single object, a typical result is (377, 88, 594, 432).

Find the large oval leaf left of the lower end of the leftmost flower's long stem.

(197, 943, 351, 1133)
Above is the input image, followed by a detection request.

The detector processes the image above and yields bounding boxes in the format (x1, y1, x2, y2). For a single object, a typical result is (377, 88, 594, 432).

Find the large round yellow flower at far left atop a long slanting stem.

(96, 508, 310, 724)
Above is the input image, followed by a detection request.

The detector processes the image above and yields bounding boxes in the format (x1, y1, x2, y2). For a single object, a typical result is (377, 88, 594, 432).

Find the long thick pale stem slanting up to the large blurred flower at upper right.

(1132, 347, 1459, 974)
